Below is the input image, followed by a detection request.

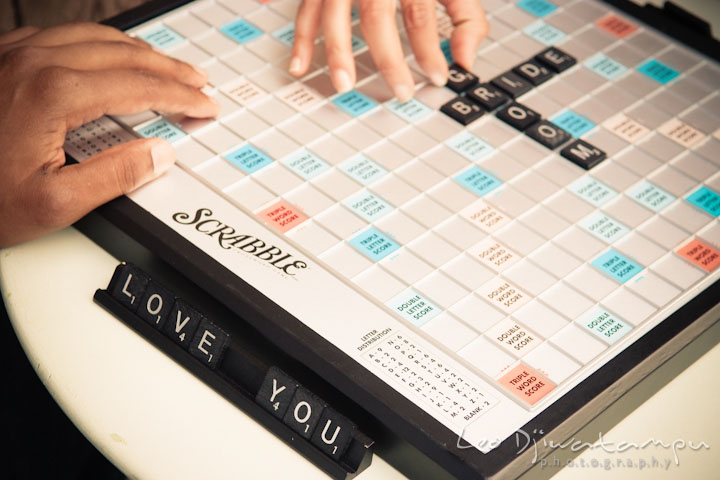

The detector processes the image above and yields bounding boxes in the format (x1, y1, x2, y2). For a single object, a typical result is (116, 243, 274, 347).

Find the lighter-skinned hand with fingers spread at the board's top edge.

(289, 0, 488, 102)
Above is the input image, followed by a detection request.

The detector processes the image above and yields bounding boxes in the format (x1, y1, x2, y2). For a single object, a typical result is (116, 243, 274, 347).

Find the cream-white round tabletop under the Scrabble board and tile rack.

(0, 228, 720, 480)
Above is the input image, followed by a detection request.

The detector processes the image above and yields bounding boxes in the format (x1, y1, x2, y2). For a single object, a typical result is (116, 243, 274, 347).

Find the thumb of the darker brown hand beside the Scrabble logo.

(51, 138, 175, 224)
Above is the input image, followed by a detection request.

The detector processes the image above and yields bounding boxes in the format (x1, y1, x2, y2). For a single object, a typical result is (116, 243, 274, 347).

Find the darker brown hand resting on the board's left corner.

(0, 23, 218, 247)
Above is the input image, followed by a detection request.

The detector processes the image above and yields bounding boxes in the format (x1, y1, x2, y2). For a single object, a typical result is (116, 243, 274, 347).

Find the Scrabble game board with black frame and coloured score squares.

(65, 0, 720, 477)
